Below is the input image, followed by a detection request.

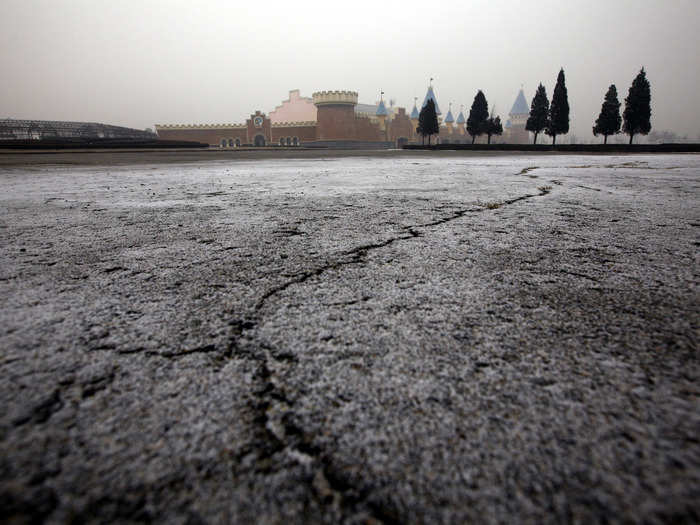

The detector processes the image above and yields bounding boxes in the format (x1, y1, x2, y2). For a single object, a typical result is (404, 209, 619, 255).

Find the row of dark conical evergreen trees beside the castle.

(416, 68, 651, 144)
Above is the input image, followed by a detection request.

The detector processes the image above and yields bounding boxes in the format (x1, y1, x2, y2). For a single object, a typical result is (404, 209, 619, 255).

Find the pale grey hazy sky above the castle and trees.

(0, 0, 700, 138)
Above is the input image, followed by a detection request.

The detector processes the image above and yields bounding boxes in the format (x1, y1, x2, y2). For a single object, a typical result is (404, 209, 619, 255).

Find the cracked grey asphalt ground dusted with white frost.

(0, 152, 700, 524)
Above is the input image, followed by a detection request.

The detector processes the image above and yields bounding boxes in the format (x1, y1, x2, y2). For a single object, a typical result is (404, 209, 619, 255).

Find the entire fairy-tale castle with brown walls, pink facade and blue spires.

(155, 85, 529, 148)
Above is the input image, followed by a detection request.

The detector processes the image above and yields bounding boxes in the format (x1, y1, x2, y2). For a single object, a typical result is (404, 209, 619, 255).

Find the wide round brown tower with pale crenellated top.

(311, 91, 357, 140)
